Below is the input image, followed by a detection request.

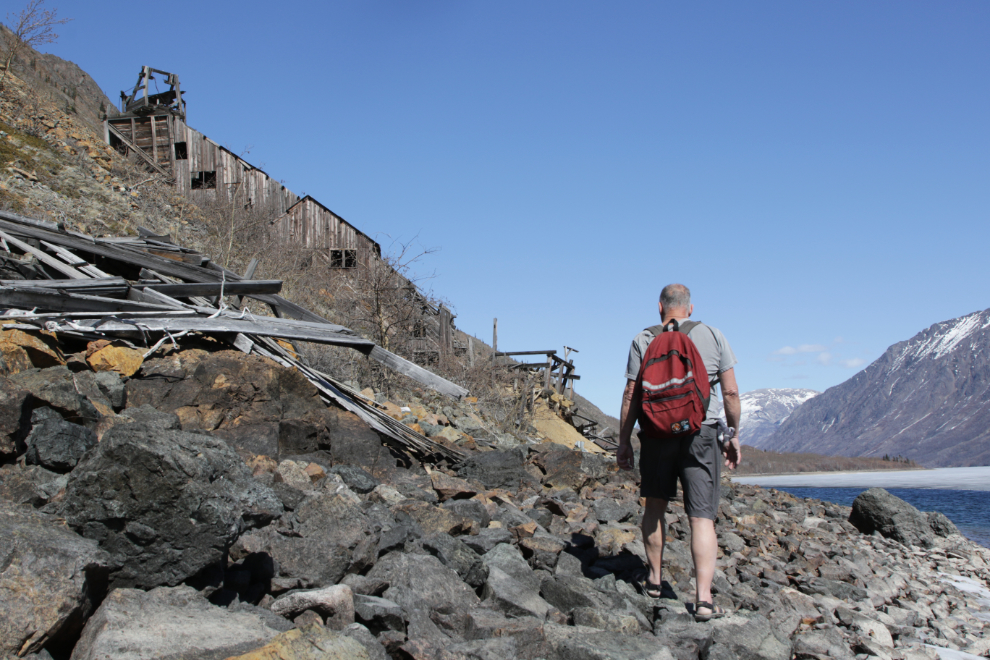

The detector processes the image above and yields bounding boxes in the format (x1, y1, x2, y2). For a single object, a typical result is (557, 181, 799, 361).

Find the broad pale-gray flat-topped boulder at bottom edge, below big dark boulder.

(72, 586, 291, 660)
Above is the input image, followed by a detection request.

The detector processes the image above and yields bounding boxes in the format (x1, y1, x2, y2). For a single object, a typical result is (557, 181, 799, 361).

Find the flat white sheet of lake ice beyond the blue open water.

(732, 464, 990, 490)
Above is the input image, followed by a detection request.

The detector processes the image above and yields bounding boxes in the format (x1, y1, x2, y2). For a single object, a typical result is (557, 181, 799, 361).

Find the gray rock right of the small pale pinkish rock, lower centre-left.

(368, 552, 479, 613)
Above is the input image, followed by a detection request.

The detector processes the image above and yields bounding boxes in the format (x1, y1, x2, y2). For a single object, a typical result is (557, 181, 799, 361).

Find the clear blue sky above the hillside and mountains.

(35, 0, 990, 414)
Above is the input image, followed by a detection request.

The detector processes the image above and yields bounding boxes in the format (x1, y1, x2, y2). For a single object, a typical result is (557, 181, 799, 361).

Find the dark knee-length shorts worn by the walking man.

(639, 425, 722, 520)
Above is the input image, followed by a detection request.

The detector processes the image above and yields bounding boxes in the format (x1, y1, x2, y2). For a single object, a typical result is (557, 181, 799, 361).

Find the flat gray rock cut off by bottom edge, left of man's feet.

(544, 623, 674, 660)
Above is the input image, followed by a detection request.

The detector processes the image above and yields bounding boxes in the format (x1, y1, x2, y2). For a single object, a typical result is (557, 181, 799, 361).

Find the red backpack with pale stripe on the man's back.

(633, 321, 711, 440)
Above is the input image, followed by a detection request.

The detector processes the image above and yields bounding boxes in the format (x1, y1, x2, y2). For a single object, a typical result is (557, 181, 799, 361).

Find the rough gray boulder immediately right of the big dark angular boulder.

(231, 491, 378, 588)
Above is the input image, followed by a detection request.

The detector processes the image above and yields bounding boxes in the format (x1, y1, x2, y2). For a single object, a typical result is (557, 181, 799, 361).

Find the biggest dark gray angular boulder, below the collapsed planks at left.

(62, 423, 282, 589)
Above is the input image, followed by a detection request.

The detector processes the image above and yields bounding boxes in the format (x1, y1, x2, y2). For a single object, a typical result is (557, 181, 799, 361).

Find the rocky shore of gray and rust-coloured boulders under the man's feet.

(0, 342, 990, 660)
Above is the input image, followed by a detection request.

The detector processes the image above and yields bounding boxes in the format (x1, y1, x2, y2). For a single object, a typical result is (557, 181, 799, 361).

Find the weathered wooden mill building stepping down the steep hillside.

(104, 66, 455, 354)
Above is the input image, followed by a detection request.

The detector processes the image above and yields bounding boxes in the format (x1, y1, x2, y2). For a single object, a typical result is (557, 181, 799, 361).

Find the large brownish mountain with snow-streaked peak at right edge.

(772, 309, 990, 466)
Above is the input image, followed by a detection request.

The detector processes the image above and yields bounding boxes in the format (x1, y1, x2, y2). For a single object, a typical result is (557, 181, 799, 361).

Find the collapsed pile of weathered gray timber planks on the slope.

(0, 211, 467, 460)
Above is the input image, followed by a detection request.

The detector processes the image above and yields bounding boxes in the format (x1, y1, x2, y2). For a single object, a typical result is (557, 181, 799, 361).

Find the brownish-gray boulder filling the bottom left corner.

(0, 500, 111, 657)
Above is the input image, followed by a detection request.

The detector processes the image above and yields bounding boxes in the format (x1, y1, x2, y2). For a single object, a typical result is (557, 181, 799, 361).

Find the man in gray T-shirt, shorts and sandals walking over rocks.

(617, 284, 742, 621)
